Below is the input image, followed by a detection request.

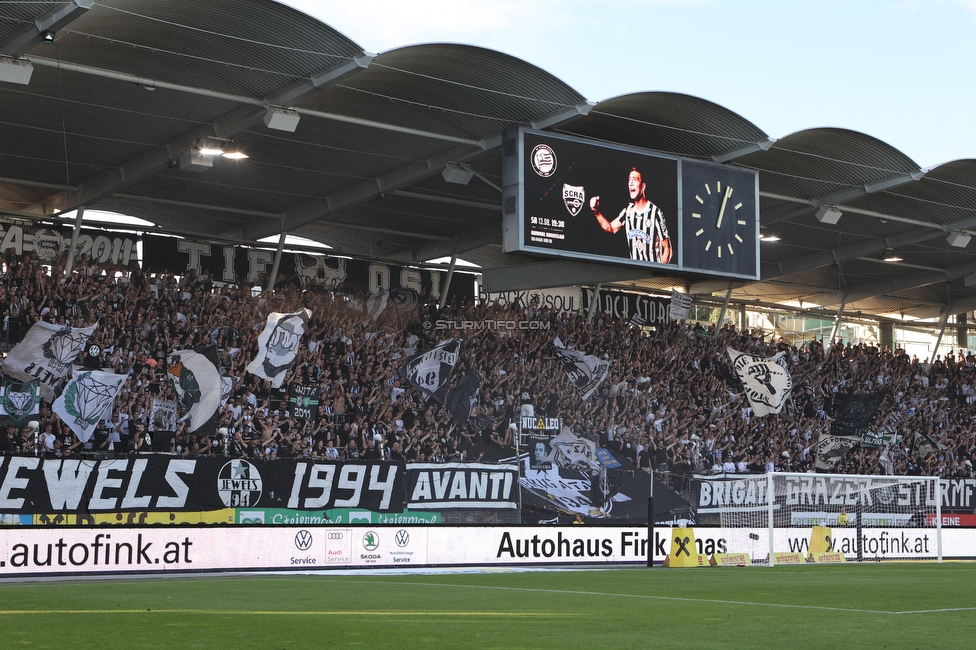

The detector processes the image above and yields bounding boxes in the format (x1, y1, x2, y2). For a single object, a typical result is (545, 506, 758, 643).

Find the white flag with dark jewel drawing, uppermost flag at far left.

(3, 321, 98, 402)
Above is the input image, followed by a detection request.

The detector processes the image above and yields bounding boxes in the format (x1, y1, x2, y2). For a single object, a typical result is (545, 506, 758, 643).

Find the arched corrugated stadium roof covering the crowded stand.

(0, 0, 976, 318)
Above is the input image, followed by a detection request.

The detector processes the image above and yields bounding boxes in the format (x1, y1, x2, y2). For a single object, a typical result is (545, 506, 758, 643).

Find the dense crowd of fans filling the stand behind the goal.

(0, 246, 976, 488)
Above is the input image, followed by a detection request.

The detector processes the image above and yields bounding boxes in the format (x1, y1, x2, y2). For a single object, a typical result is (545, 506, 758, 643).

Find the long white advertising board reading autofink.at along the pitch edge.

(0, 526, 964, 578)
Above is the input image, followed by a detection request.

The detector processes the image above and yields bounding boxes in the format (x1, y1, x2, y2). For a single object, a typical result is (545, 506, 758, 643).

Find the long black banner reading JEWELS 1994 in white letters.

(0, 454, 403, 514)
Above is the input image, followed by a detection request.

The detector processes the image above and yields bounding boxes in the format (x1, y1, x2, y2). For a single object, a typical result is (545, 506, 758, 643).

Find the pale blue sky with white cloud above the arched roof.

(285, 0, 976, 167)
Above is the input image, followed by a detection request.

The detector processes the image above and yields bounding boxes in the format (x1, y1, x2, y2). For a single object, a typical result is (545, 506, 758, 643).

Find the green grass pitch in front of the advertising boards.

(0, 563, 976, 650)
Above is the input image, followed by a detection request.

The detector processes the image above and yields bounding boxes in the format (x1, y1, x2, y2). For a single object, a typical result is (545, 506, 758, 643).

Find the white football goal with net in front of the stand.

(701, 473, 942, 564)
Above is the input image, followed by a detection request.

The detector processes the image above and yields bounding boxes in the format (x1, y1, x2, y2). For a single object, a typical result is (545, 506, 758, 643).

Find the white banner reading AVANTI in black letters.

(405, 463, 518, 510)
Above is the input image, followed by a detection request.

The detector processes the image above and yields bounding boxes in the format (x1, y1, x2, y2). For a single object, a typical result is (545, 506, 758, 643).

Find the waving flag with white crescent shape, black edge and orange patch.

(167, 345, 221, 432)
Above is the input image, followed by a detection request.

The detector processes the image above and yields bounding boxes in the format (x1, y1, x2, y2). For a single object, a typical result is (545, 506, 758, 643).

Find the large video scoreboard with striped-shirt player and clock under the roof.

(502, 129, 759, 279)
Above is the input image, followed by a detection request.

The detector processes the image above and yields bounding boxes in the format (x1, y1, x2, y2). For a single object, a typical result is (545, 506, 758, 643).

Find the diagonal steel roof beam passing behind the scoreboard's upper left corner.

(241, 103, 593, 239)
